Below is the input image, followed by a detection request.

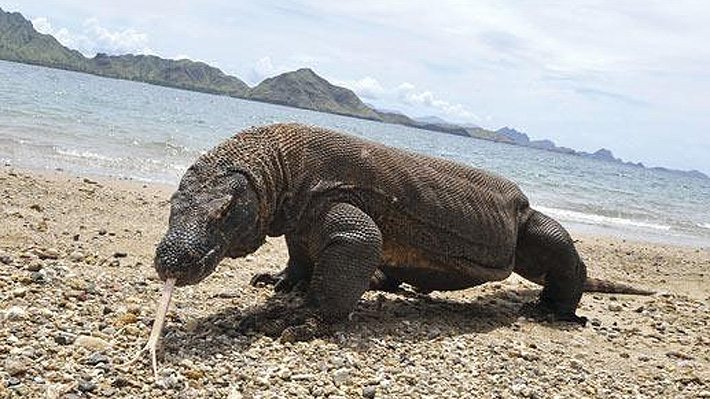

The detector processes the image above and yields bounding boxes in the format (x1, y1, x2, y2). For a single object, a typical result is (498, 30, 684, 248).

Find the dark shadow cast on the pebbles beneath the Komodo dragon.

(163, 289, 573, 358)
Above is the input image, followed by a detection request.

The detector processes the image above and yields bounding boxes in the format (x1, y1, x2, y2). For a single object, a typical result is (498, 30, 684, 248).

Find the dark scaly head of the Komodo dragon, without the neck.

(155, 162, 265, 286)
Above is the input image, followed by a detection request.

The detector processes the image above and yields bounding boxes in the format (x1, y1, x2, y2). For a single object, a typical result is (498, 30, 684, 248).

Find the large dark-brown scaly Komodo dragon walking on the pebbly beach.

(155, 124, 649, 340)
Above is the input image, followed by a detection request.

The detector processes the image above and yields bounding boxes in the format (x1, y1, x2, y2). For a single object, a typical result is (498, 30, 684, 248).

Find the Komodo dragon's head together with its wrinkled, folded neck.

(155, 131, 292, 286)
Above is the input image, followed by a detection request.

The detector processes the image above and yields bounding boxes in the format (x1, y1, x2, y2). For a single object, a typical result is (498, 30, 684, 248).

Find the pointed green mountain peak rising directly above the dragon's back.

(248, 68, 382, 121)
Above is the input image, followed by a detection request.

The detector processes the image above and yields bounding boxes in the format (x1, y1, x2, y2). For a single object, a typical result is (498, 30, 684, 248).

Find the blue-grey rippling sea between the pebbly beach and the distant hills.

(0, 61, 710, 246)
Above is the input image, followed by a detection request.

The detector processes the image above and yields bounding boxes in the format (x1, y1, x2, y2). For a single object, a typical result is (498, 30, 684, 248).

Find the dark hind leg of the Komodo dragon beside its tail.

(514, 210, 587, 324)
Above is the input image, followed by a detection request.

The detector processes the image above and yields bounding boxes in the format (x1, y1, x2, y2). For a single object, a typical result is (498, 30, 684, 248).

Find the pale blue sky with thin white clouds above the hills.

(0, 0, 710, 174)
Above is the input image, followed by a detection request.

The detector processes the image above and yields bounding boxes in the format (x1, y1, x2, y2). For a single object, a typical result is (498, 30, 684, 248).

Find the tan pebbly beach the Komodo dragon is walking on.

(0, 167, 710, 398)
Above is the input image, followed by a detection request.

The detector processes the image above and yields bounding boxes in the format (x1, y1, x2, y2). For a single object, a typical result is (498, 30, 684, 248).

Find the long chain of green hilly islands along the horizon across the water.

(0, 8, 710, 179)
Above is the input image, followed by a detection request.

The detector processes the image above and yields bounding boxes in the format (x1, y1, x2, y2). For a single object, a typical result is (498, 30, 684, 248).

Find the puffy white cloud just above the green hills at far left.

(32, 17, 155, 57)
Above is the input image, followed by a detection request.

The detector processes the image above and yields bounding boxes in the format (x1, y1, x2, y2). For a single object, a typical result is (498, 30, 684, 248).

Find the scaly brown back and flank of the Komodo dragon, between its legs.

(253, 125, 528, 276)
